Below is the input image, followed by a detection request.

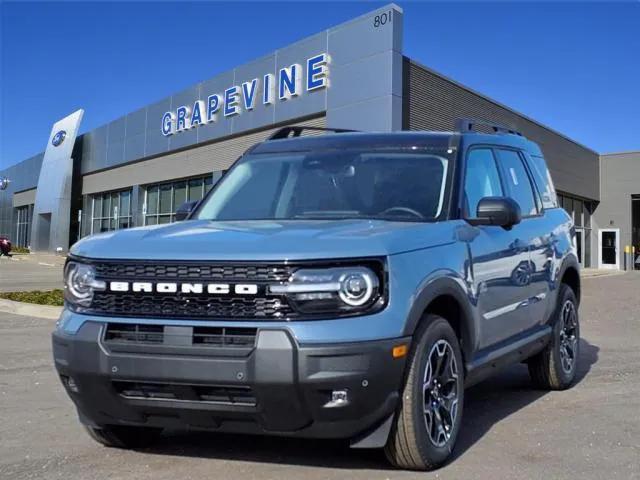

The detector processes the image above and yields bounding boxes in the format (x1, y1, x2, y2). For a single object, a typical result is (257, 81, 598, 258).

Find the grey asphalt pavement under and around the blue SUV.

(0, 272, 640, 480)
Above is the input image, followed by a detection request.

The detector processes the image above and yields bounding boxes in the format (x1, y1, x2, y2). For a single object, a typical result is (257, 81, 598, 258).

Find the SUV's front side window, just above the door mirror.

(464, 148, 503, 218)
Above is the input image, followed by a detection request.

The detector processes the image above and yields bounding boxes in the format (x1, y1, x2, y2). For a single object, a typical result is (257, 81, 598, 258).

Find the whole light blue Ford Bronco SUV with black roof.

(53, 120, 580, 470)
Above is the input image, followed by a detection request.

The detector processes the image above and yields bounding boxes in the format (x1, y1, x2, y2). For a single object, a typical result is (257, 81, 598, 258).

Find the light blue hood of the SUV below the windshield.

(71, 220, 454, 260)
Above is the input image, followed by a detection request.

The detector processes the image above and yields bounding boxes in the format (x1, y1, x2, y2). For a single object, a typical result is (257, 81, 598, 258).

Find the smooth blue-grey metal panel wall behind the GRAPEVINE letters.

(81, 4, 403, 175)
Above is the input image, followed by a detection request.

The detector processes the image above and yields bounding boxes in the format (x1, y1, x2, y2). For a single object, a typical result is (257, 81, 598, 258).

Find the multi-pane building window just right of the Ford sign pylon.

(91, 188, 133, 234)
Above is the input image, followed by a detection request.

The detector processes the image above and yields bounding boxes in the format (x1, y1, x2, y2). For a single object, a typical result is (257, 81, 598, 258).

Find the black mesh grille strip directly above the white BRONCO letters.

(95, 262, 293, 282)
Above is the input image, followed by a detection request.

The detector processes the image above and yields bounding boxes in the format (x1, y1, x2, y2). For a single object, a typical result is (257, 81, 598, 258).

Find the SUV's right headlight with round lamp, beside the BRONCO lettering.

(269, 267, 381, 313)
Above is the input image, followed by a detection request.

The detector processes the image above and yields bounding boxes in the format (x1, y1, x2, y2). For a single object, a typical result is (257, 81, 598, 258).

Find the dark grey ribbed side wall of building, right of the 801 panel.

(404, 58, 600, 200)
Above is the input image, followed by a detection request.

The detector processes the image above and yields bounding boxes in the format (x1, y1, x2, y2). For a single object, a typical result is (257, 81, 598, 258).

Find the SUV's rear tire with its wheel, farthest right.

(528, 283, 580, 390)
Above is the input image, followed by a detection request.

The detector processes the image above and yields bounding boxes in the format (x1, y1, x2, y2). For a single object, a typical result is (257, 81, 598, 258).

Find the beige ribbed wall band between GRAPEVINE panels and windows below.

(82, 117, 325, 195)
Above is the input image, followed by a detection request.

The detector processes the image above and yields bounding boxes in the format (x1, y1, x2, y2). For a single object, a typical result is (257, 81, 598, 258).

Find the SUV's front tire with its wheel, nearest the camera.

(385, 315, 464, 470)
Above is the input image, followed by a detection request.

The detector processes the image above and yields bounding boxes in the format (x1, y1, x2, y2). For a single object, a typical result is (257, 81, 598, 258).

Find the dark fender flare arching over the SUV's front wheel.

(403, 276, 478, 359)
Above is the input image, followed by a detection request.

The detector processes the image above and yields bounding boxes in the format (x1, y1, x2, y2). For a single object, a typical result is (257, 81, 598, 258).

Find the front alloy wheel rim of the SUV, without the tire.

(422, 340, 459, 447)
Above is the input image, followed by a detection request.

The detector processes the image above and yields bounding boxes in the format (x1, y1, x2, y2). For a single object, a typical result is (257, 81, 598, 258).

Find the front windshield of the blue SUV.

(193, 150, 448, 221)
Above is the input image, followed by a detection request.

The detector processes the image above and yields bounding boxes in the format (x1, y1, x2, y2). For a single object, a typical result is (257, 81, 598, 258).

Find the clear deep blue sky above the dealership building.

(0, 0, 640, 168)
